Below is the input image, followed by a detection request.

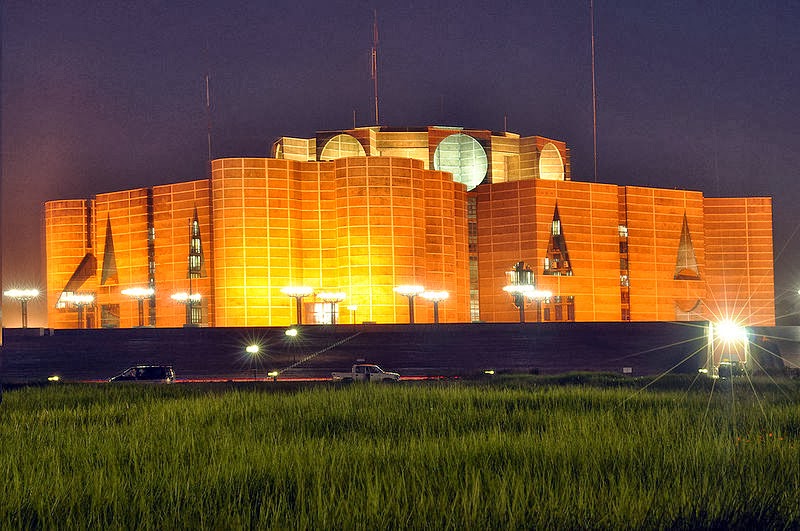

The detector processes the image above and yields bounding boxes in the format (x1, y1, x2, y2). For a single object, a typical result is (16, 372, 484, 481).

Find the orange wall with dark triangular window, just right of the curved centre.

(475, 180, 620, 322)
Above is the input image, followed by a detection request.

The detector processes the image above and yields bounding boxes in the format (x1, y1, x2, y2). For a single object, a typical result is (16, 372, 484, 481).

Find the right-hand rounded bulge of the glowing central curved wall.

(336, 157, 469, 323)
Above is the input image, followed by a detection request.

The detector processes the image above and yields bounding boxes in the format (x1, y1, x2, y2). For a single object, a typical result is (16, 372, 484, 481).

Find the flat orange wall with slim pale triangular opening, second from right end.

(621, 186, 707, 321)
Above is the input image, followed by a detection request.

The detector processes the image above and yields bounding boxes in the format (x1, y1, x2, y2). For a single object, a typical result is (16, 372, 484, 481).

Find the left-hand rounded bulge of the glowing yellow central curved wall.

(211, 158, 304, 326)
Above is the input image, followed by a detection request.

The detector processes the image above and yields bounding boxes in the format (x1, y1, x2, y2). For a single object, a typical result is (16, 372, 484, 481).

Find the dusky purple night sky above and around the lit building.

(2, 0, 800, 327)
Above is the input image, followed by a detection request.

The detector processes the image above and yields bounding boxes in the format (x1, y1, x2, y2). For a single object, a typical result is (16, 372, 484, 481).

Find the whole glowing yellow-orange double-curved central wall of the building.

(212, 157, 469, 326)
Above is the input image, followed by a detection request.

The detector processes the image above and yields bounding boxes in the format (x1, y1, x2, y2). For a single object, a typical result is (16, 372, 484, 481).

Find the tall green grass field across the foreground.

(0, 375, 800, 529)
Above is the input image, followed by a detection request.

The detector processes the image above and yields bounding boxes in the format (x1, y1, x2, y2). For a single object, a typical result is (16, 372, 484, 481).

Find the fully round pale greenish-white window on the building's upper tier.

(433, 133, 489, 190)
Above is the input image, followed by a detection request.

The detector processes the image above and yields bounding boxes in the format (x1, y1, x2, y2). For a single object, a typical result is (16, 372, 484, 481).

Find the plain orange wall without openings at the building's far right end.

(704, 197, 775, 326)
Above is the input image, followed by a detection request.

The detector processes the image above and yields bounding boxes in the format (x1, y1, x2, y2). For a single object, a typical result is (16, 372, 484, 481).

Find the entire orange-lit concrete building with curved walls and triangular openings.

(44, 127, 775, 328)
